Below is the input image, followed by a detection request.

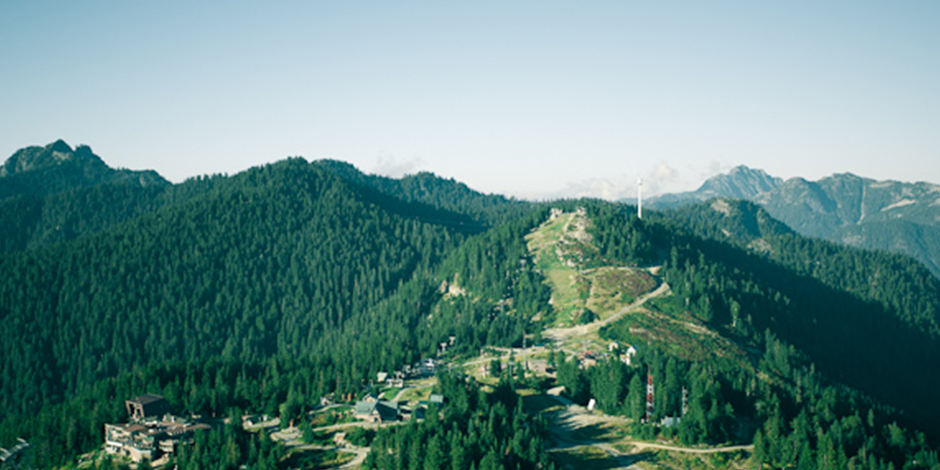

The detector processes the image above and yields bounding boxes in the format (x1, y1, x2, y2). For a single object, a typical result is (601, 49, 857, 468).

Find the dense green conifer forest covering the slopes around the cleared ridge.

(0, 144, 940, 470)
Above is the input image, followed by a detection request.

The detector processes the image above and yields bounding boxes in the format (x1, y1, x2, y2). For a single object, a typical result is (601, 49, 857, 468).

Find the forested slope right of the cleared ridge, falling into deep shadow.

(556, 201, 940, 469)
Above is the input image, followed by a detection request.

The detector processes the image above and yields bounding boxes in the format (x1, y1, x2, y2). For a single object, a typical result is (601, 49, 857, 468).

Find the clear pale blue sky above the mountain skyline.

(0, 0, 940, 197)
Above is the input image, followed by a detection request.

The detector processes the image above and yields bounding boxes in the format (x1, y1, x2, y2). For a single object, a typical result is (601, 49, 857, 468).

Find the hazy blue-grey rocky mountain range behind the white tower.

(647, 166, 940, 277)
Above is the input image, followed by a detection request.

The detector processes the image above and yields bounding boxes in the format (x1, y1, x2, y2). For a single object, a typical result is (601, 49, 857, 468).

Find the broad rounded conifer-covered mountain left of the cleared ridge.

(0, 156, 478, 420)
